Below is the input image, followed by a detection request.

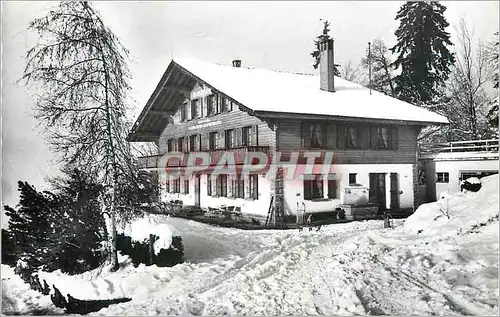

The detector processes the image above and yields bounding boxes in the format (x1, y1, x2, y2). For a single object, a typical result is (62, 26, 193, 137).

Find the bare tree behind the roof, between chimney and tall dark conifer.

(361, 39, 396, 97)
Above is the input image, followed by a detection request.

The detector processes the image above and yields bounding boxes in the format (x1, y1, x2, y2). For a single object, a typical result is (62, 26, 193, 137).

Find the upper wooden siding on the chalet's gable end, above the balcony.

(159, 85, 275, 154)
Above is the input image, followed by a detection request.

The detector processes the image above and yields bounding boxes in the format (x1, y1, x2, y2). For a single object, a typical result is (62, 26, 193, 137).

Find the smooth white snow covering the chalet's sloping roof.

(173, 57, 448, 123)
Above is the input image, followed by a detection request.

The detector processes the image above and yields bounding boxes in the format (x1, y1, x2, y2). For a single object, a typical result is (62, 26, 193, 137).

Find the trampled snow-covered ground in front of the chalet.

(2, 176, 499, 315)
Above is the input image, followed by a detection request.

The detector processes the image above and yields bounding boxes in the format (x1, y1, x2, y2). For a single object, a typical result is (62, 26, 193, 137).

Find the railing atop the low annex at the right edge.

(419, 139, 498, 154)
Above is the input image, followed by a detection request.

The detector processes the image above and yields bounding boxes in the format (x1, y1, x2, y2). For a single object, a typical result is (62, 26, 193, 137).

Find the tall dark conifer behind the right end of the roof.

(391, 1, 455, 104)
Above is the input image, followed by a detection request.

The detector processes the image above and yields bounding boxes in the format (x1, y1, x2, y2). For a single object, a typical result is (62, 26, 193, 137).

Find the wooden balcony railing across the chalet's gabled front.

(138, 146, 269, 169)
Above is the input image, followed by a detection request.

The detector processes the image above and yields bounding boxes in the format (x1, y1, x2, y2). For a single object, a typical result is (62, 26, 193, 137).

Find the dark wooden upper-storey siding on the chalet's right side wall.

(276, 119, 421, 164)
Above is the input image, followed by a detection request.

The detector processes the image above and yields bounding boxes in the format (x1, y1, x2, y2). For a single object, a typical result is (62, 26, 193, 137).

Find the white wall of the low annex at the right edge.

(424, 158, 498, 201)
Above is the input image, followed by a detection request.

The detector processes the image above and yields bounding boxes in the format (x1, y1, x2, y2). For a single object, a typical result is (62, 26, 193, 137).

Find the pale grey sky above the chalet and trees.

(1, 1, 499, 221)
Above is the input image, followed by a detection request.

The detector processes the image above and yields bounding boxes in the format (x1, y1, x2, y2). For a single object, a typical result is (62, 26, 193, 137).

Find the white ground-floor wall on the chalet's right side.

(284, 164, 414, 215)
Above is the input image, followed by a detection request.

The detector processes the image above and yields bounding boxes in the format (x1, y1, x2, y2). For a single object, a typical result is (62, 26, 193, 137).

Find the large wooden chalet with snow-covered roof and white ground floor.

(129, 41, 448, 222)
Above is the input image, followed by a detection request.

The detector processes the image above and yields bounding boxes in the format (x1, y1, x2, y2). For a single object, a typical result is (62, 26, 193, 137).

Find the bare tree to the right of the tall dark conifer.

(447, 18, 490, 140)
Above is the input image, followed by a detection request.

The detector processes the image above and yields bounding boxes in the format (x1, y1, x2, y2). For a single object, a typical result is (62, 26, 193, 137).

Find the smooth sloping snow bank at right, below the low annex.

(404, 174, 499, 236)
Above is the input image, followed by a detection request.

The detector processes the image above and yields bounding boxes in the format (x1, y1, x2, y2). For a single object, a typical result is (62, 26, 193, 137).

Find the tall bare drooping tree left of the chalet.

(22, 1, 135, 269)
